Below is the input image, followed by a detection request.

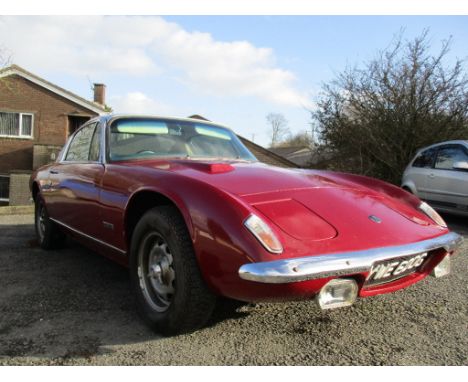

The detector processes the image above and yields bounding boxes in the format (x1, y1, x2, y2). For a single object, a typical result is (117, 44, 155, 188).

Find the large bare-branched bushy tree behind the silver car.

(312, 31, 468, 184)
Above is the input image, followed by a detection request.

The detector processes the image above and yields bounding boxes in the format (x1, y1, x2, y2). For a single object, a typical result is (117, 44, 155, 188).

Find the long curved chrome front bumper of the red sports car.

(239, 232, 463, 284)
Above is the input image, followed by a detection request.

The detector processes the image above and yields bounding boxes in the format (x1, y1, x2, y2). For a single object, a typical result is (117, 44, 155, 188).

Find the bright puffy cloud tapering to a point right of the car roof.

(148, 23, 307, 106)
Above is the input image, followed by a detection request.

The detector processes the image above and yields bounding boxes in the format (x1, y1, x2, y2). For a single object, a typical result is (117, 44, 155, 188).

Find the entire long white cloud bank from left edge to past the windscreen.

(0, 16, 308, 106)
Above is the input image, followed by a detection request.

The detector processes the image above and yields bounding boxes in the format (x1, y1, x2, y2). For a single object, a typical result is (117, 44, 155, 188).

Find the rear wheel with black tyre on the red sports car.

(34, 195, 66, 249)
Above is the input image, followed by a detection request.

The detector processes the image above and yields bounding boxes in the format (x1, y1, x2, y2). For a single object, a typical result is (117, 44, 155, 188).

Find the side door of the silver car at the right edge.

(427, 144, 468, 208)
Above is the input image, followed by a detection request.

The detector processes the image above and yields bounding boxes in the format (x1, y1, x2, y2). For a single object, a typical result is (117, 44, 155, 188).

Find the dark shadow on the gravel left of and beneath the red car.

(0, 225, 252, 364)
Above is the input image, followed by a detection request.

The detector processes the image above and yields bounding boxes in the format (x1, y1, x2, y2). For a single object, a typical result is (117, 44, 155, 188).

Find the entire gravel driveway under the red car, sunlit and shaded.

(0, 215, 468, 365)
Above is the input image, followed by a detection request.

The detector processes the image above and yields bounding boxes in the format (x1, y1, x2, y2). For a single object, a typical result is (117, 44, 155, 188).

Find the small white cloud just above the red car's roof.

(110, 91, 173, 115)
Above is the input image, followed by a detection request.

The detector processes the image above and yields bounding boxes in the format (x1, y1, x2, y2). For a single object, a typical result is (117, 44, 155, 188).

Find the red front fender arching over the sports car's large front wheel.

(119, 172, 274, 299)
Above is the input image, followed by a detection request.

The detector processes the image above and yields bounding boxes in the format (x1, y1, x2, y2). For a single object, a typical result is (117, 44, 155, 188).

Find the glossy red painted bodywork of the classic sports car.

(31, 116, 458, 301)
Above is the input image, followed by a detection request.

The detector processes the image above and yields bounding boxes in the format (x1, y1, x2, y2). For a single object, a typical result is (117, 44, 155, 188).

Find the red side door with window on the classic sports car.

(49, 122, 104, 237)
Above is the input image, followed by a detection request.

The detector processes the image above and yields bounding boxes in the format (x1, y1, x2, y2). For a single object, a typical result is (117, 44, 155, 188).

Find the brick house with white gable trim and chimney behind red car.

(0, 65, 105, 202)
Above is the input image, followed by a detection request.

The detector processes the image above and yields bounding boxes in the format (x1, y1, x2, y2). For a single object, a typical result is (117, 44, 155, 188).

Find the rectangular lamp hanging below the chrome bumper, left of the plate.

(316, 279, 359, 309)
